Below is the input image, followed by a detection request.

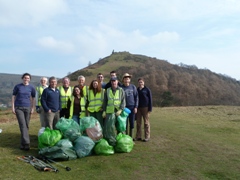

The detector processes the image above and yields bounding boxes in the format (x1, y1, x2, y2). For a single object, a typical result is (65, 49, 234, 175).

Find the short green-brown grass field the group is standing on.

(0, 106, 240, 180)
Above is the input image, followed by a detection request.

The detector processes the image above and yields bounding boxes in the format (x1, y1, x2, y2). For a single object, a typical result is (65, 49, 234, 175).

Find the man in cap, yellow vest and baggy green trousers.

(102, 77, 126, 146)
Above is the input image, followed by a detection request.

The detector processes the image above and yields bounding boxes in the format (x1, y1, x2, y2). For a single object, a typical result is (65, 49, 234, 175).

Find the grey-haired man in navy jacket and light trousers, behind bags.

(41, 76, 61, 129)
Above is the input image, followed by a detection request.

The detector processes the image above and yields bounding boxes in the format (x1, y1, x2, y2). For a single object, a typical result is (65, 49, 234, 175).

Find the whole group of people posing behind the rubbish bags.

(12, 71, 152, 150)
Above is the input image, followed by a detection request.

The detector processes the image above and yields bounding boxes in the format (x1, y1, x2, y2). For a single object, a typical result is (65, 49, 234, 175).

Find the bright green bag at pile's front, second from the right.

(94, 139, 114, 155)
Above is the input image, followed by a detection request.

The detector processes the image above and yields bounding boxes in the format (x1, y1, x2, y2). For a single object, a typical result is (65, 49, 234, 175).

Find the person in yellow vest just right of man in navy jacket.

(58, 77, 73, 119)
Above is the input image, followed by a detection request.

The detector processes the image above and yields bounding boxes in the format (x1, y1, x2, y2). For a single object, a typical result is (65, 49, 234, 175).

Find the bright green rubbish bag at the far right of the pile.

(115, 133, 134, 153)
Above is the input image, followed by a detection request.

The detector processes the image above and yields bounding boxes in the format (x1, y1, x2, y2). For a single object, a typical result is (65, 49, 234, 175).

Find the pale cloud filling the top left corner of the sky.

(0, 0, 68, 27)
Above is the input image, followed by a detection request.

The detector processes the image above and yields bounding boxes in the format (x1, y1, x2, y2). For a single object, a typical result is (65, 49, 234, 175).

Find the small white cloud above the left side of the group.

(37, 36, 74, 53)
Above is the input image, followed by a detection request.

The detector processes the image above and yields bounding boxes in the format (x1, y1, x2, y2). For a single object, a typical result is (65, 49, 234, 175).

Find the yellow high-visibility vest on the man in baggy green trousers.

(106, 88, 122, 113)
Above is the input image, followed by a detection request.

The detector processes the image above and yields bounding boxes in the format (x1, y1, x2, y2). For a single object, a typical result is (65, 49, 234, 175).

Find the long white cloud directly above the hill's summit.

(76, 24, 180, 55)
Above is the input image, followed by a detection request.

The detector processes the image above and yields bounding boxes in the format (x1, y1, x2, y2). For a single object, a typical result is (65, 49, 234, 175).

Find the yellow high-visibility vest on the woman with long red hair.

(88, 89, 104, 113)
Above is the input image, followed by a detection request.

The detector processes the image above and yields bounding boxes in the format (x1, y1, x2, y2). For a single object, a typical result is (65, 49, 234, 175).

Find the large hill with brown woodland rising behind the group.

(69, 52, 240, 106)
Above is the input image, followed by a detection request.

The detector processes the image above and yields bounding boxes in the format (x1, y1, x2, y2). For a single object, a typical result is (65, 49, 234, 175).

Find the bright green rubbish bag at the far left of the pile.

(38, 127, 62, 149)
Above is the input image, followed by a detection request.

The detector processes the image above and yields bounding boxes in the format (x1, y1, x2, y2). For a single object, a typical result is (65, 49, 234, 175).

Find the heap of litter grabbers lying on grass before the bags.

(17, 156, 59, 172)
